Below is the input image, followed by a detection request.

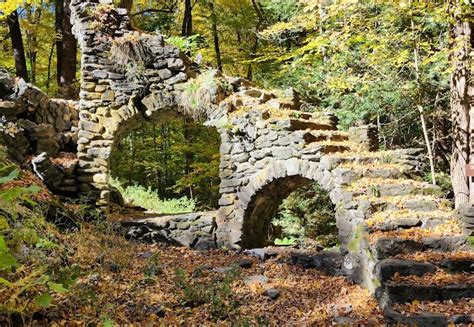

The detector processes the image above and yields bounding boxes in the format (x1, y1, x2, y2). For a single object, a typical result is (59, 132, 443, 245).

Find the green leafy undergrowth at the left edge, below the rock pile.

(0, 148, 74, 324)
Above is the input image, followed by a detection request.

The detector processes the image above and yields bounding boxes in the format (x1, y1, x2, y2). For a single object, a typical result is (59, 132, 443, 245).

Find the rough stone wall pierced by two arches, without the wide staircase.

(71, 0, 378, 288)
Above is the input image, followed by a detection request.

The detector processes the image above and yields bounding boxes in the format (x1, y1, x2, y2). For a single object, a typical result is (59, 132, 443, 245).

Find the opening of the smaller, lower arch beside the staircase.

(241, 175, 338, 249)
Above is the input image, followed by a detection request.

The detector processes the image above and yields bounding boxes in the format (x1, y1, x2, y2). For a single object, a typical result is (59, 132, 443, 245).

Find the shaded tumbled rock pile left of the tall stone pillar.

(0, 69, 79, 194)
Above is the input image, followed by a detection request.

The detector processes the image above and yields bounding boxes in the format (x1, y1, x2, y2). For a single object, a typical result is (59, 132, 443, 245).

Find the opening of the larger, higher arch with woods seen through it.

(109, 110, 220, 214)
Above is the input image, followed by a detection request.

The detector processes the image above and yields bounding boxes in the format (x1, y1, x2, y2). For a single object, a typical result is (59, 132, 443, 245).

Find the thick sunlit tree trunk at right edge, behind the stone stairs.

(450, 0, 474, 208)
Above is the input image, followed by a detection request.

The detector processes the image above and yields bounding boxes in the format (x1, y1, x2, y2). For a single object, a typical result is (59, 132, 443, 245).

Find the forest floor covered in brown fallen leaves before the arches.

(31, 223, 383, 326)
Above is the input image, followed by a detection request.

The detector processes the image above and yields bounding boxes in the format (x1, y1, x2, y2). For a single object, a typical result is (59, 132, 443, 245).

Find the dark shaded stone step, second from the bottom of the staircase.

(384, 282, 474, 303)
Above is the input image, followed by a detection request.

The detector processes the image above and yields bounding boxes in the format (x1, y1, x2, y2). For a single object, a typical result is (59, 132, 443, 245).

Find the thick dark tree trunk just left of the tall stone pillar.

(55, 0, 77, 99)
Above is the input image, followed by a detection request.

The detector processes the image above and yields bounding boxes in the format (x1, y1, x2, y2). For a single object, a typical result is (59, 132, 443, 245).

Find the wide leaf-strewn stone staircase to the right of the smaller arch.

(333, 147, 474, 326)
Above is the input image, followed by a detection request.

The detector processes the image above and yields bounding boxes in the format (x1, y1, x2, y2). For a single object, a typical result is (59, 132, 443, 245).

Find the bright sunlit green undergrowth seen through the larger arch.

(109, 178, 196, 214)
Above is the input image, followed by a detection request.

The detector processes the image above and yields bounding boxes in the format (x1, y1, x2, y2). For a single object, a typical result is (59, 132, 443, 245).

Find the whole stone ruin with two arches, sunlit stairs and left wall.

(0, 0, 473, 321)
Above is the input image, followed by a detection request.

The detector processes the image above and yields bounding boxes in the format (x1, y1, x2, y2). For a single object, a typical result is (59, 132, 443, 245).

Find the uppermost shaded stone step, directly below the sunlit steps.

(371, 235, 467, 260)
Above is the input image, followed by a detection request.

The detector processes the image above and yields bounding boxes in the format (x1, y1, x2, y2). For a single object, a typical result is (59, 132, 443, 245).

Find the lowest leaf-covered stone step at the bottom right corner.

(384, 299, 474, 327)
